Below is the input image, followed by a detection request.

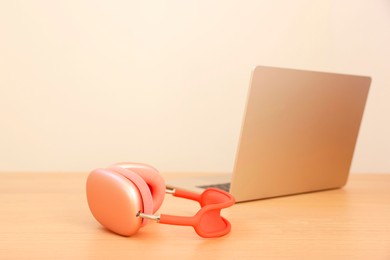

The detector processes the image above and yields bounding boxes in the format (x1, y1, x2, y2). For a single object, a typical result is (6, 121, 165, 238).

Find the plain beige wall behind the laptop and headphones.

(0, 0, 390, 175)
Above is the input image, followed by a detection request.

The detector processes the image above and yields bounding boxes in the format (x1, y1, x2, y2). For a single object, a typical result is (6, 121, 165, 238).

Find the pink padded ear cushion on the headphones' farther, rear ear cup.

(114, 163, 165, 213)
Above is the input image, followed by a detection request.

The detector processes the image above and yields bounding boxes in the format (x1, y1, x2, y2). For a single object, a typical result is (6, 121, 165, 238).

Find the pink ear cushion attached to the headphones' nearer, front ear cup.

(108, 166, 154, 226)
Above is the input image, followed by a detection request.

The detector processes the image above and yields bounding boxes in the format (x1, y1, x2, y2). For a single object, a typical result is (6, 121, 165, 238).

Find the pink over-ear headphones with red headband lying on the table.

(87, 163, 235, 237)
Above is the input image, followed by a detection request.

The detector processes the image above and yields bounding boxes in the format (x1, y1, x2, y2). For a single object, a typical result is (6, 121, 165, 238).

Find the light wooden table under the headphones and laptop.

(0, 173, 390, 259)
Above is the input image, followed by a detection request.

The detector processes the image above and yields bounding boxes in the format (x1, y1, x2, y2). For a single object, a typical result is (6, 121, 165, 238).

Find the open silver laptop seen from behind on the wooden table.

(167, 66, 371, 202)
